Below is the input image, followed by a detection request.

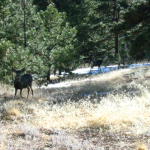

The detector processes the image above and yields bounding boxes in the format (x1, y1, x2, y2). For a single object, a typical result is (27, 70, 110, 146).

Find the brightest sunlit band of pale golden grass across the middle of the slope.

(29, 87, 150, 134)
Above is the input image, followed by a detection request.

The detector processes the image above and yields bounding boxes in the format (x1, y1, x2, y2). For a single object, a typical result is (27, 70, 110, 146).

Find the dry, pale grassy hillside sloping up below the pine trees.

(0, 67, 150, 150)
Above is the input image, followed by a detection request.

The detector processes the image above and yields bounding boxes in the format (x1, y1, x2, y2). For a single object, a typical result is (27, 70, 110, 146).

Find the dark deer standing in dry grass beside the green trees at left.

(12, 68, 33, 98)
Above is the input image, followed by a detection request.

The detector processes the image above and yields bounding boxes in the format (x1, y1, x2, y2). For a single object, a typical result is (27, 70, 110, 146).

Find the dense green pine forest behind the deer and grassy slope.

(0, 0, 150, 83)
